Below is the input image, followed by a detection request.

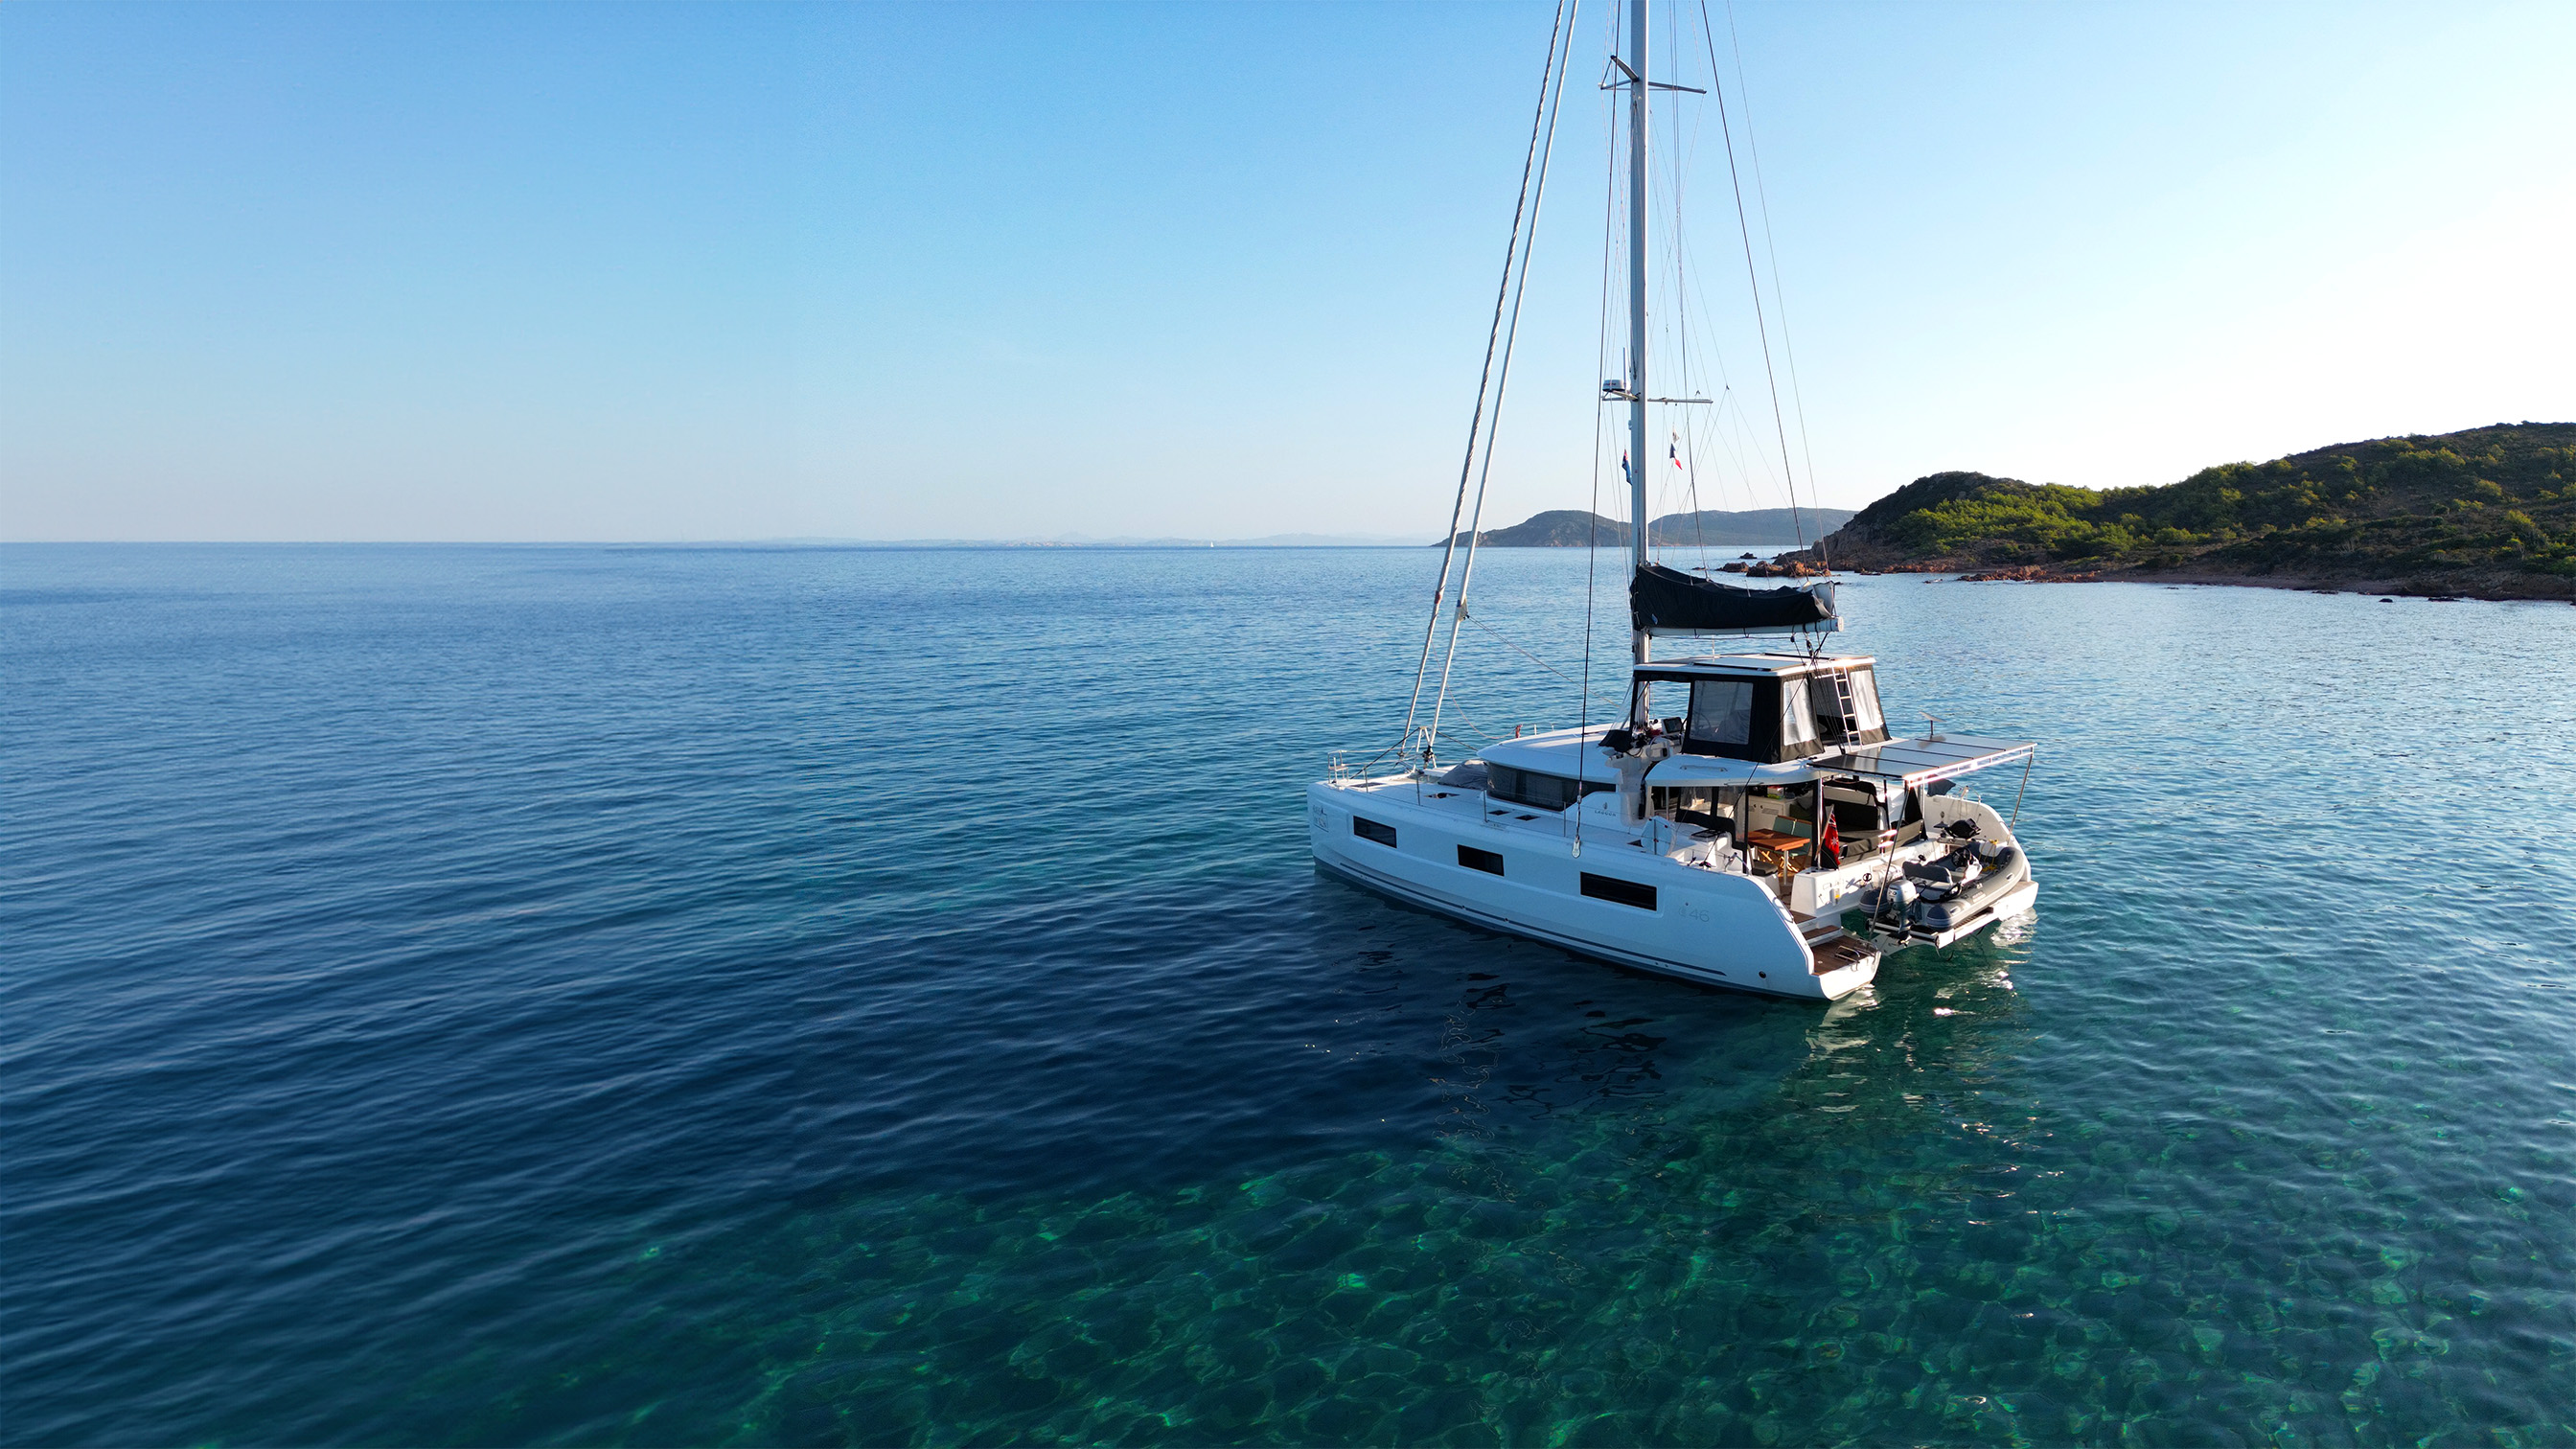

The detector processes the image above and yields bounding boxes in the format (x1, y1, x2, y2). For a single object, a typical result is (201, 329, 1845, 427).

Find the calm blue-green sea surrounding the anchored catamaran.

(0, 546, 2576, 1446)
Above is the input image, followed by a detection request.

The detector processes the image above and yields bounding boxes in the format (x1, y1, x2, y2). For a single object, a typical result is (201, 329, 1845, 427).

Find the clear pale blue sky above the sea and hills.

(0, 0, 2576, 539)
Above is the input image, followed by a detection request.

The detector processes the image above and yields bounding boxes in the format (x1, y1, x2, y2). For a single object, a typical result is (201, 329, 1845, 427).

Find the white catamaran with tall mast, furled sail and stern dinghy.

(1306, 0, 2037, 1000)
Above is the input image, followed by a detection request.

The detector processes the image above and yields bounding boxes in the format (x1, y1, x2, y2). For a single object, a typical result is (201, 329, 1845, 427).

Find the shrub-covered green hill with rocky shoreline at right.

(1804, 423, 2576, 598)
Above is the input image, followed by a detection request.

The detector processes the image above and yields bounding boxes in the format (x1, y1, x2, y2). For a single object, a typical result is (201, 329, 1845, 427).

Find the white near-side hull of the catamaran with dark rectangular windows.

(1306, 781, 1878, 1000)
